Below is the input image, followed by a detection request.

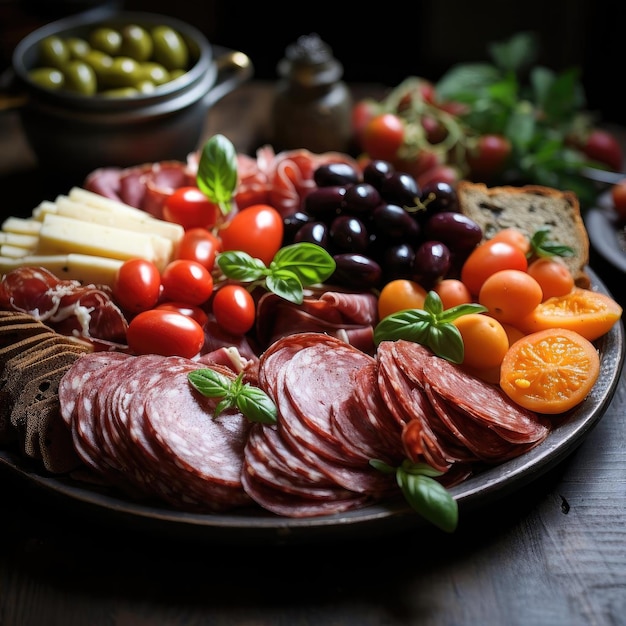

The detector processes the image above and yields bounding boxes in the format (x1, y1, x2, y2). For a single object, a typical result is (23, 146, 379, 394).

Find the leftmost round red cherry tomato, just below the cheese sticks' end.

(113, 258, 161, 313)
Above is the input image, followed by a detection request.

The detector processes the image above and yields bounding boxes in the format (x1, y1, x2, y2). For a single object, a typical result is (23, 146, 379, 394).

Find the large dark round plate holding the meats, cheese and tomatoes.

(0, 271, 624, 544)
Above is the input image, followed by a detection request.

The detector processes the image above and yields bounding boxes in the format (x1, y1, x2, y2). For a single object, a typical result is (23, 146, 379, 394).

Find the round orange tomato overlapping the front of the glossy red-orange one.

(478, 270, 543, 325)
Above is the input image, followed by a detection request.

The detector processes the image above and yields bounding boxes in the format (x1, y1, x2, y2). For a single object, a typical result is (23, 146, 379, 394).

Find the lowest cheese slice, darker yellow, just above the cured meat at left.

(0, 253, 123, 287)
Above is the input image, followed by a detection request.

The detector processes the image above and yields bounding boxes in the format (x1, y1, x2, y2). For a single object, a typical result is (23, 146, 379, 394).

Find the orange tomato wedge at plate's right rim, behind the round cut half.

(515, 287, 622, 341)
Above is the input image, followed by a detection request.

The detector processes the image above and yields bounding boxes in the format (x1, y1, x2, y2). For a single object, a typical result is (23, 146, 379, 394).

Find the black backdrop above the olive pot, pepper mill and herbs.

(0, 0, 626, 124)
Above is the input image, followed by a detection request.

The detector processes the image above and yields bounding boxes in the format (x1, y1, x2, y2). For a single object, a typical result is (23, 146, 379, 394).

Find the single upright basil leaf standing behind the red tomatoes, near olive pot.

(196, 135, 238, 215)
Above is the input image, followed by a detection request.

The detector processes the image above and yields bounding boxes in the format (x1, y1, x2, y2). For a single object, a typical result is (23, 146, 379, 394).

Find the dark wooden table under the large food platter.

(0, 82, 626, 626)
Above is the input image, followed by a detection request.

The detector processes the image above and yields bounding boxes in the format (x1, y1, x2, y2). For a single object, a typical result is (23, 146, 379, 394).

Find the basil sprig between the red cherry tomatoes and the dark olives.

(216, 242, 336, 304)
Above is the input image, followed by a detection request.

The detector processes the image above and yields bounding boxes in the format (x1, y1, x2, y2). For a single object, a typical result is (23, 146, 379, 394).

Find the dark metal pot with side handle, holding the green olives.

(6, 11, 253, 176)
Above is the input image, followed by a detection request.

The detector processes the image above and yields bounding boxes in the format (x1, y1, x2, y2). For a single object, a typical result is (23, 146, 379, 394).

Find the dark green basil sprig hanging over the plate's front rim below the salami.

(370, 459, 459, 533)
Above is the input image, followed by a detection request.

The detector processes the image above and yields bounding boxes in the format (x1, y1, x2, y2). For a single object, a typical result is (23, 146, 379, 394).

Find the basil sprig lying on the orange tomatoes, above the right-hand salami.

(374, 291, 487, 363)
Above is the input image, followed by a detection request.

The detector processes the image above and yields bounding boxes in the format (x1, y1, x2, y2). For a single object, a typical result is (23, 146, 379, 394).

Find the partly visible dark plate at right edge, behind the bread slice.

(585, 192, 626, 272)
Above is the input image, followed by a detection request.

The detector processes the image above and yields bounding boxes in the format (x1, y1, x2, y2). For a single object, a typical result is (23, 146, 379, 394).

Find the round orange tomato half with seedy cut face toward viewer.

(500, 328, 600, 414)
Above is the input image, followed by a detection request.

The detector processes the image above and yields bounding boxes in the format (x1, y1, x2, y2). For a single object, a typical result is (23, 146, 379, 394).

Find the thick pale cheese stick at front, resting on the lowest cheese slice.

(37, 213, 174, 271)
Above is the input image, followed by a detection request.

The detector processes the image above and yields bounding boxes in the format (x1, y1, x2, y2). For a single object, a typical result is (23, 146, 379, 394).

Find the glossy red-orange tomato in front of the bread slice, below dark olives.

(461, 240, 528, 296)
